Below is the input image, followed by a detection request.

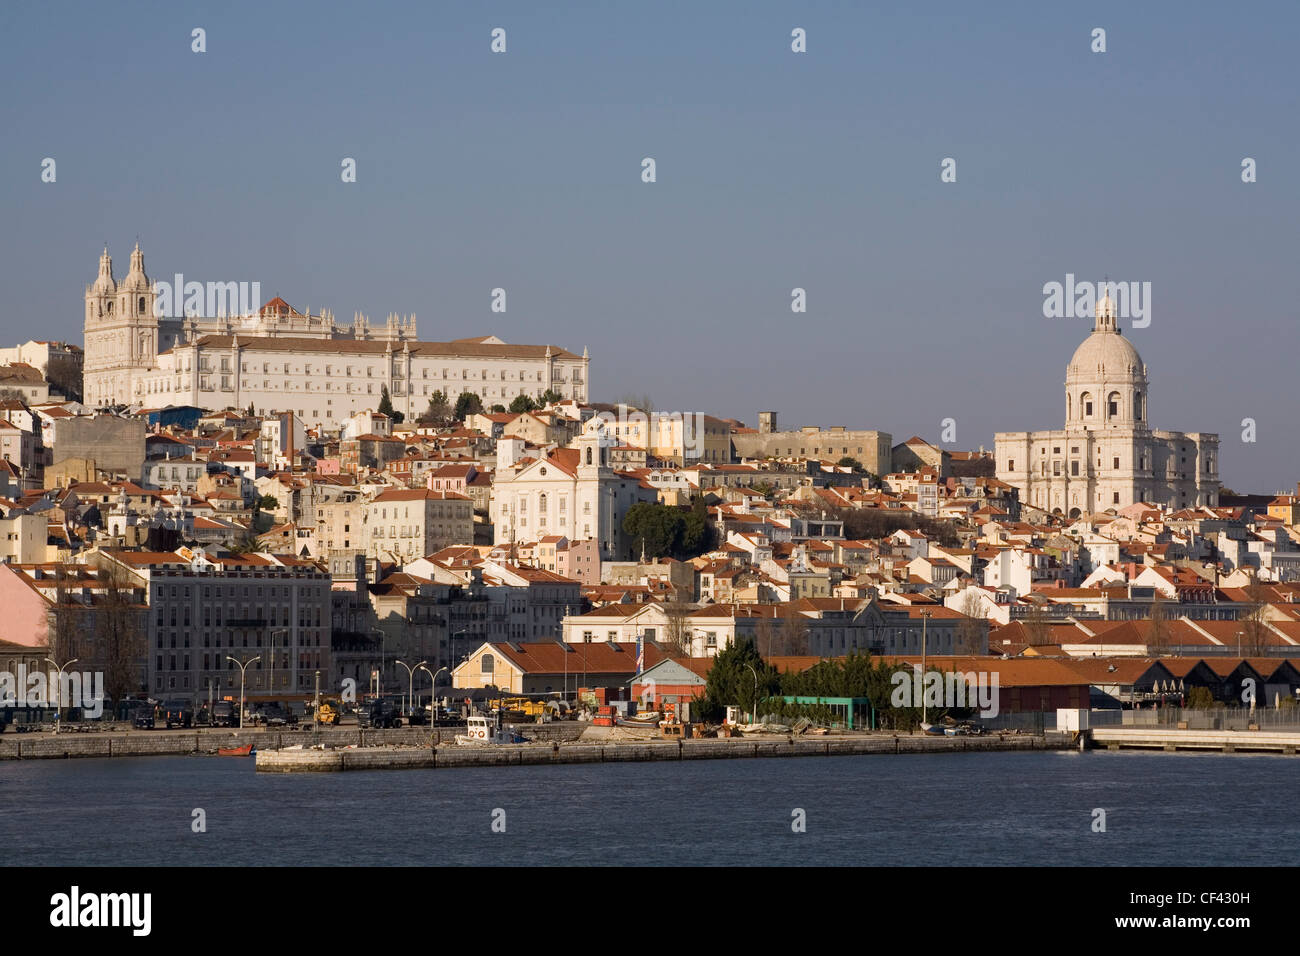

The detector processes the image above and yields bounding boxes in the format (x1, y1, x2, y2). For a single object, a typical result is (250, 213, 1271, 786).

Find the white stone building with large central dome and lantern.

(995, 293, 1219, 518)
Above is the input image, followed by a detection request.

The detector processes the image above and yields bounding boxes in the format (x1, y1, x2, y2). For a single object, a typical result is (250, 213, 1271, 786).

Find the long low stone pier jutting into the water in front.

(256, 734, 1071, 774)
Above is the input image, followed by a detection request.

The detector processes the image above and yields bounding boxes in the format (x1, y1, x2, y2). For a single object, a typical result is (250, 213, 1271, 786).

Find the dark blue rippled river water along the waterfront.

(0, 752, 1300, 866)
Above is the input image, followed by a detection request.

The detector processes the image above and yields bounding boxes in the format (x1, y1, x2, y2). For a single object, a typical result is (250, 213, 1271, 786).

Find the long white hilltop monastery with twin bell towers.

(83, 245, 590, 428)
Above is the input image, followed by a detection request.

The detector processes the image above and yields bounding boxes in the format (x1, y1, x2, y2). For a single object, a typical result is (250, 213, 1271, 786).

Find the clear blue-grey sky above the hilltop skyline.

(0, 1, 1300, 492)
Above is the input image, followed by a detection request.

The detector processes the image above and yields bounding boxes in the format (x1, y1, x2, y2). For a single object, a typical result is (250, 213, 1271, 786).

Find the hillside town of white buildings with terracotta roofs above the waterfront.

(0, 246, 1300, 713)
